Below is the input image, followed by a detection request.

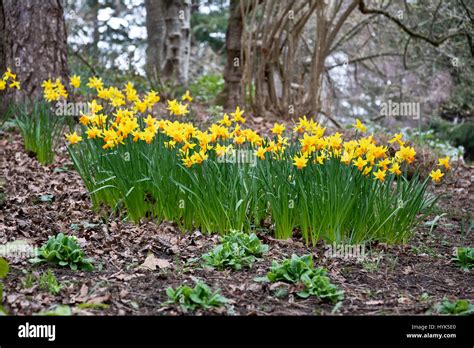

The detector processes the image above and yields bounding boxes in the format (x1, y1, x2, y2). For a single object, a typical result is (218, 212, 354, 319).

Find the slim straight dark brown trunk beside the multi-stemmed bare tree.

(224, 0, 243, 109)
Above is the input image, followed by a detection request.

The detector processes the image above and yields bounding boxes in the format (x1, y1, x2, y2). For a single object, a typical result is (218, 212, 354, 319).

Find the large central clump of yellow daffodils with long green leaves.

(49, 76, 450, 245)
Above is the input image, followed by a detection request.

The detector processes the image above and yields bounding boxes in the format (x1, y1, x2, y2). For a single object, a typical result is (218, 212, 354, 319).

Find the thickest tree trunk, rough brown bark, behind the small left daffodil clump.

(1, 0, 68, 104)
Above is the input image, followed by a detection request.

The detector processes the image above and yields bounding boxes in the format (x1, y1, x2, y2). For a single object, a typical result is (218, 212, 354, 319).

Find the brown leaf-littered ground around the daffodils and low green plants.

(0, 133, 474, 315)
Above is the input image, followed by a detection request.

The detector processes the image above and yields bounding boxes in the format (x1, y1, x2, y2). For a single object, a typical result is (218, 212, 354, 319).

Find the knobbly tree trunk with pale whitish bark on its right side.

(145, 0, 191, 86)
